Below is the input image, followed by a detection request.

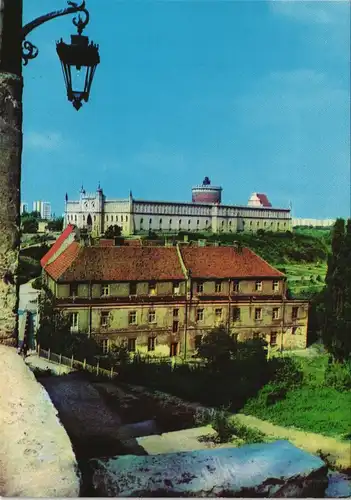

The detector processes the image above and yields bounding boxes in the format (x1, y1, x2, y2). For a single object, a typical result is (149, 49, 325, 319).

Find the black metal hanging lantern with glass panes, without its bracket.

(56, 11, 100, 111)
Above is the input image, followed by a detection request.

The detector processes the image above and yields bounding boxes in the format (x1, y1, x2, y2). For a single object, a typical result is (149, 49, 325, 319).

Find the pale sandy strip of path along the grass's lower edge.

(236, 414, 351, 472)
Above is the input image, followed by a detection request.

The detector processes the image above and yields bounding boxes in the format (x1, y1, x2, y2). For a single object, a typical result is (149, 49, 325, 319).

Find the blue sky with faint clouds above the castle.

(22, 0, 350, 218)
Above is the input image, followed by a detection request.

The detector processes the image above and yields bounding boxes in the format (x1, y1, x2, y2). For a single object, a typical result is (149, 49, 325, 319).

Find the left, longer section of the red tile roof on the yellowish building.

(46, 245, 184, 282)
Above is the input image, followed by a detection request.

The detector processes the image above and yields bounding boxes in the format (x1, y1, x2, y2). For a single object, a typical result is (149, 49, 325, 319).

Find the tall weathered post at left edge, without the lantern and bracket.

(0, 0, 23, 346)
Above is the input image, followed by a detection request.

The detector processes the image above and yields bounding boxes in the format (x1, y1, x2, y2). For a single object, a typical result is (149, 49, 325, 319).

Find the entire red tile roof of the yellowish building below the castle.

(45, 238, 284, 282)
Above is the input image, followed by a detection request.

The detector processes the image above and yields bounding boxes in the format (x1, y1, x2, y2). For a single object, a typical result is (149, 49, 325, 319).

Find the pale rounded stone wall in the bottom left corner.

(0, 346, 80, 498)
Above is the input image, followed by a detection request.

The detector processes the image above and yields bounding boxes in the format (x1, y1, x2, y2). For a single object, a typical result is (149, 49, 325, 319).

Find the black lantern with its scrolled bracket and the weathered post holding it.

(0, 0, 100, 345)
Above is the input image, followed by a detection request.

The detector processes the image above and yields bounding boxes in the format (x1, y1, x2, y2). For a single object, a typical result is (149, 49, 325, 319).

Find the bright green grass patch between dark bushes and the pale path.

(243, 356, 351, 438)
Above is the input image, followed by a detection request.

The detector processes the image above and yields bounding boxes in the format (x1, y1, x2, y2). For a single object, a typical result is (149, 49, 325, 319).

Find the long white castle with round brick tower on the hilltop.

(64, 177, 292, 236)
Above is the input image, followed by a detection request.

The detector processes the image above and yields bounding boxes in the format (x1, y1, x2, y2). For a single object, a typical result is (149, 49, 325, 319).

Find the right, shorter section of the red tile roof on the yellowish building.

(181, 247, 284, 279)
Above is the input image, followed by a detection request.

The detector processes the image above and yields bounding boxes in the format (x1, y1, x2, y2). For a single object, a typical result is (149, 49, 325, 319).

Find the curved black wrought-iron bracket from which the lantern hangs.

(22, 0, 89, 66)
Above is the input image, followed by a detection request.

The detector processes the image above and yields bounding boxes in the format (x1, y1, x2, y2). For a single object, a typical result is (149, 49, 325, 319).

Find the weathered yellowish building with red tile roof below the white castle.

(41, 226, 308, 357)
